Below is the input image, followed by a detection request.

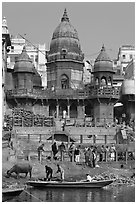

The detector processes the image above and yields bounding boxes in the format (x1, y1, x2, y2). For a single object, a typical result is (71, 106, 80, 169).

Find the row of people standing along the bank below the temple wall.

(38, 142, 116, 167)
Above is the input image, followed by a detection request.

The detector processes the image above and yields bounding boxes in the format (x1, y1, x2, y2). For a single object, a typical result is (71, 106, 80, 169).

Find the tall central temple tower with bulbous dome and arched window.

(47, 9, 84, 89)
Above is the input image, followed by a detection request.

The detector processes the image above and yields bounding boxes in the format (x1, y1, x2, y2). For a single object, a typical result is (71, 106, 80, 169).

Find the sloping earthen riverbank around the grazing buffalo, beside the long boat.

(2, 152, 135, 187)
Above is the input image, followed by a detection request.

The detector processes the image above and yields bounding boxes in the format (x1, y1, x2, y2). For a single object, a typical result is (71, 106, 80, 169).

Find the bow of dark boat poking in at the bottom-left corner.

(2, 188, 24, 202)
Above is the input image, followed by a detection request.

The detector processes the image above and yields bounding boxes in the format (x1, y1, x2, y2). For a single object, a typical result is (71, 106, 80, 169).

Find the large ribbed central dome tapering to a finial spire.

(49, 9, 83, 61)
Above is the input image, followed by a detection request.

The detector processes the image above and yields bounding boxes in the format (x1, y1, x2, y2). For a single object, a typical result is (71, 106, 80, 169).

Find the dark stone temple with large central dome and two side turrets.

(5, 10, 119, 131)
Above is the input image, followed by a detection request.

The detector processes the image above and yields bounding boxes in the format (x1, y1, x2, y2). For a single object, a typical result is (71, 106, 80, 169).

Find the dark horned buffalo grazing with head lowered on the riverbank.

(7, 163, 32, 178)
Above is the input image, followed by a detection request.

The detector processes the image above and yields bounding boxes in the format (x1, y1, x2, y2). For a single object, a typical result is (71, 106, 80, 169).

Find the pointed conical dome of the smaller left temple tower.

(14, 46, 34, 73)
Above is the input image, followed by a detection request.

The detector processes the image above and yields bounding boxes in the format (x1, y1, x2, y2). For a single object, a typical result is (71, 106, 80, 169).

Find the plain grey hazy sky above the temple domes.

(2, 2, 135, 59)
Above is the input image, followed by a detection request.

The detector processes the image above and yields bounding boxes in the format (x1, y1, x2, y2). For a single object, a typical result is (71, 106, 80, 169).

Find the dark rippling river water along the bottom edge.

(5, 185, 135, 202)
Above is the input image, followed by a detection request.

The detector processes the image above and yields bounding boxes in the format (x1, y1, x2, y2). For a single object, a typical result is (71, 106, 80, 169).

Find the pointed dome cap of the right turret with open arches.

(94, 45, 113, 72)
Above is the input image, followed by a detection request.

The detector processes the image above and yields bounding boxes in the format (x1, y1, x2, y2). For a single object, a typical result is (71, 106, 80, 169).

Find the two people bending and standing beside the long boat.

(45, 164, 64, 181)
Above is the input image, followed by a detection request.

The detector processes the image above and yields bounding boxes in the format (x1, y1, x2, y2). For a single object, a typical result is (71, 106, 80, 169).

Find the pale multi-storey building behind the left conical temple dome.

(7, 36, 47, 88)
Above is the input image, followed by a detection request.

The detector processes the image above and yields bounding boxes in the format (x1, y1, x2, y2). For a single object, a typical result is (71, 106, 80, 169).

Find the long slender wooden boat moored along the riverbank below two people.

(27, 180, 114, 188)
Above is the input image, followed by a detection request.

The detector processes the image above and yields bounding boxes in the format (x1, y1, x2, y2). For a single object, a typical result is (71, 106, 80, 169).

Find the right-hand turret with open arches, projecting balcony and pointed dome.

(91, 45, 119, 123)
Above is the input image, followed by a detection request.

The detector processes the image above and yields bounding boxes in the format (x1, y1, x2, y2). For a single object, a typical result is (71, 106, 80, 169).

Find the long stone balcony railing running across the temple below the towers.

(6, 87, 120, 99)
